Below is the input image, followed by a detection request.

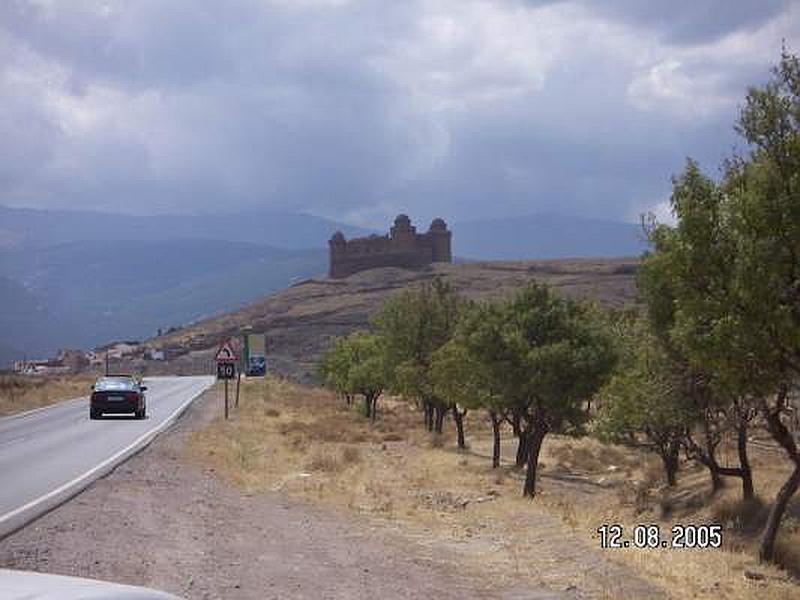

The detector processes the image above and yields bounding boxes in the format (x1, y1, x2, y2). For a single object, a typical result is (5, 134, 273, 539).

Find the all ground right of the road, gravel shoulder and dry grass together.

(0, 378, 798, 600)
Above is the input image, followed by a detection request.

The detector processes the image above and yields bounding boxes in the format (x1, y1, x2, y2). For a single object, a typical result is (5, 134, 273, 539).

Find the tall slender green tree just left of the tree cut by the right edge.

(638, 166, 755, 499)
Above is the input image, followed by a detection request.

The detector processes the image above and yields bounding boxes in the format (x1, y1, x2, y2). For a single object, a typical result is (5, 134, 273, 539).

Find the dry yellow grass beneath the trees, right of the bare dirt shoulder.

(188, 379, 800, 600)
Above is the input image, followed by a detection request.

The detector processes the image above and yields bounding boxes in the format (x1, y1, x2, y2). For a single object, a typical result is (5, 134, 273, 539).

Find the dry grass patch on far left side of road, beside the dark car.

(0, 375, 95, 416)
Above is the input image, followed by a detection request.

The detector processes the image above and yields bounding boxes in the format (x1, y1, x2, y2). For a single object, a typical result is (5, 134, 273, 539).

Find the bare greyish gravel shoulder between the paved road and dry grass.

(0, 392, 581, 599)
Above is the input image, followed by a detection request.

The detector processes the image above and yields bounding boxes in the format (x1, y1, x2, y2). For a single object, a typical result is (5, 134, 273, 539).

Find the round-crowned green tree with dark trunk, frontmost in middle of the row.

(468, 282, 614, 497)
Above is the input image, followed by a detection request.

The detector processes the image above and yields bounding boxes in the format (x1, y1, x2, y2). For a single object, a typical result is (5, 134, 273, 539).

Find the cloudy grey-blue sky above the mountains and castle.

(0, 0, 800, 229)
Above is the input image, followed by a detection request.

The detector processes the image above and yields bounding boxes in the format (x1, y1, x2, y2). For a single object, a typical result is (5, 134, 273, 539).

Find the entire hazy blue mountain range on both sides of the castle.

(0, 206, 644, 365)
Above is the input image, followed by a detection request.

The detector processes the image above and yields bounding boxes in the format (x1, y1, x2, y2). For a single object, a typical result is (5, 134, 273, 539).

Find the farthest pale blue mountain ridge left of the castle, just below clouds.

(0, 206, 370, 249)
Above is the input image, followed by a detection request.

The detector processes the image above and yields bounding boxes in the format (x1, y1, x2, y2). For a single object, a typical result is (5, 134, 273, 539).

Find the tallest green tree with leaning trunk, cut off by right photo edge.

(724, 50, 800, 560)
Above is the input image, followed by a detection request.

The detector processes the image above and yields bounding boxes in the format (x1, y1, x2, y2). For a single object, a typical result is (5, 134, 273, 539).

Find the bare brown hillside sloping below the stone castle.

(149, 258, 637, 380)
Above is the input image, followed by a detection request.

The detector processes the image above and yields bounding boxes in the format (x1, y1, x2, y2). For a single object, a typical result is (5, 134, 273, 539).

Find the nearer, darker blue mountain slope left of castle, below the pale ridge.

(0, 239, 327, 356)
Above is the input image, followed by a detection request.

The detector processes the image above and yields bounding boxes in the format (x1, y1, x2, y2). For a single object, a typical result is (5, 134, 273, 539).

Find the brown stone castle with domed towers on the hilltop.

(328, 215, 453, 278)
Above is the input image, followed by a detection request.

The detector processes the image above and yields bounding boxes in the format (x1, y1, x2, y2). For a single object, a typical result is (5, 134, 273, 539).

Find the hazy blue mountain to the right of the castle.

(451, 214, 646, 260)
